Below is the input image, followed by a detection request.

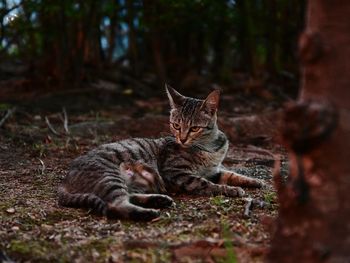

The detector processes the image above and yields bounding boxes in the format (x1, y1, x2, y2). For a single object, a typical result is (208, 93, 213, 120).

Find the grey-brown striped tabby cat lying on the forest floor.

(59, 86, 262, 220)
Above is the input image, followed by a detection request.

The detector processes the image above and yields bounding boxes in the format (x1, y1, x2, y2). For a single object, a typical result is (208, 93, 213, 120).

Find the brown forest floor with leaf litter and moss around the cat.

(0, 85, 287, 262)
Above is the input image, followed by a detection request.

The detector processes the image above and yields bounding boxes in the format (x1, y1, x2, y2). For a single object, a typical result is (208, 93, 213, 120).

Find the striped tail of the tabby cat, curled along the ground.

(58, 186, 107, 215)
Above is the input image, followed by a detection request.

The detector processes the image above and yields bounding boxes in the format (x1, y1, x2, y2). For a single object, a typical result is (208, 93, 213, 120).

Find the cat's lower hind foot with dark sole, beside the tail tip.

(106, 195, 159, 221)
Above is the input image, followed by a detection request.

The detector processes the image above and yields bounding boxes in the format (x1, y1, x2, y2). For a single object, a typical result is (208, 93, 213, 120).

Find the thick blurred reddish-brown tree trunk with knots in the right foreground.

(269, 0, 350, 262)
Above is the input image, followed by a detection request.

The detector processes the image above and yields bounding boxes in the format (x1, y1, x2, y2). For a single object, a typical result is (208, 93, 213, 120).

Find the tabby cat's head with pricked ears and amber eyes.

(166, 85, 220, 148)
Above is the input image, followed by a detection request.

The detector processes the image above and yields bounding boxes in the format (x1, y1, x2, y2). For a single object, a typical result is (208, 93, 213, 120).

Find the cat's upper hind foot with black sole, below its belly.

(129, 194, 174, 208)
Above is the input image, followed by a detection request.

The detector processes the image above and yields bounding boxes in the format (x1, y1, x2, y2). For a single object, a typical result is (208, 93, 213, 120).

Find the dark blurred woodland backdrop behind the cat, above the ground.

(0, 0, 305, 106)
